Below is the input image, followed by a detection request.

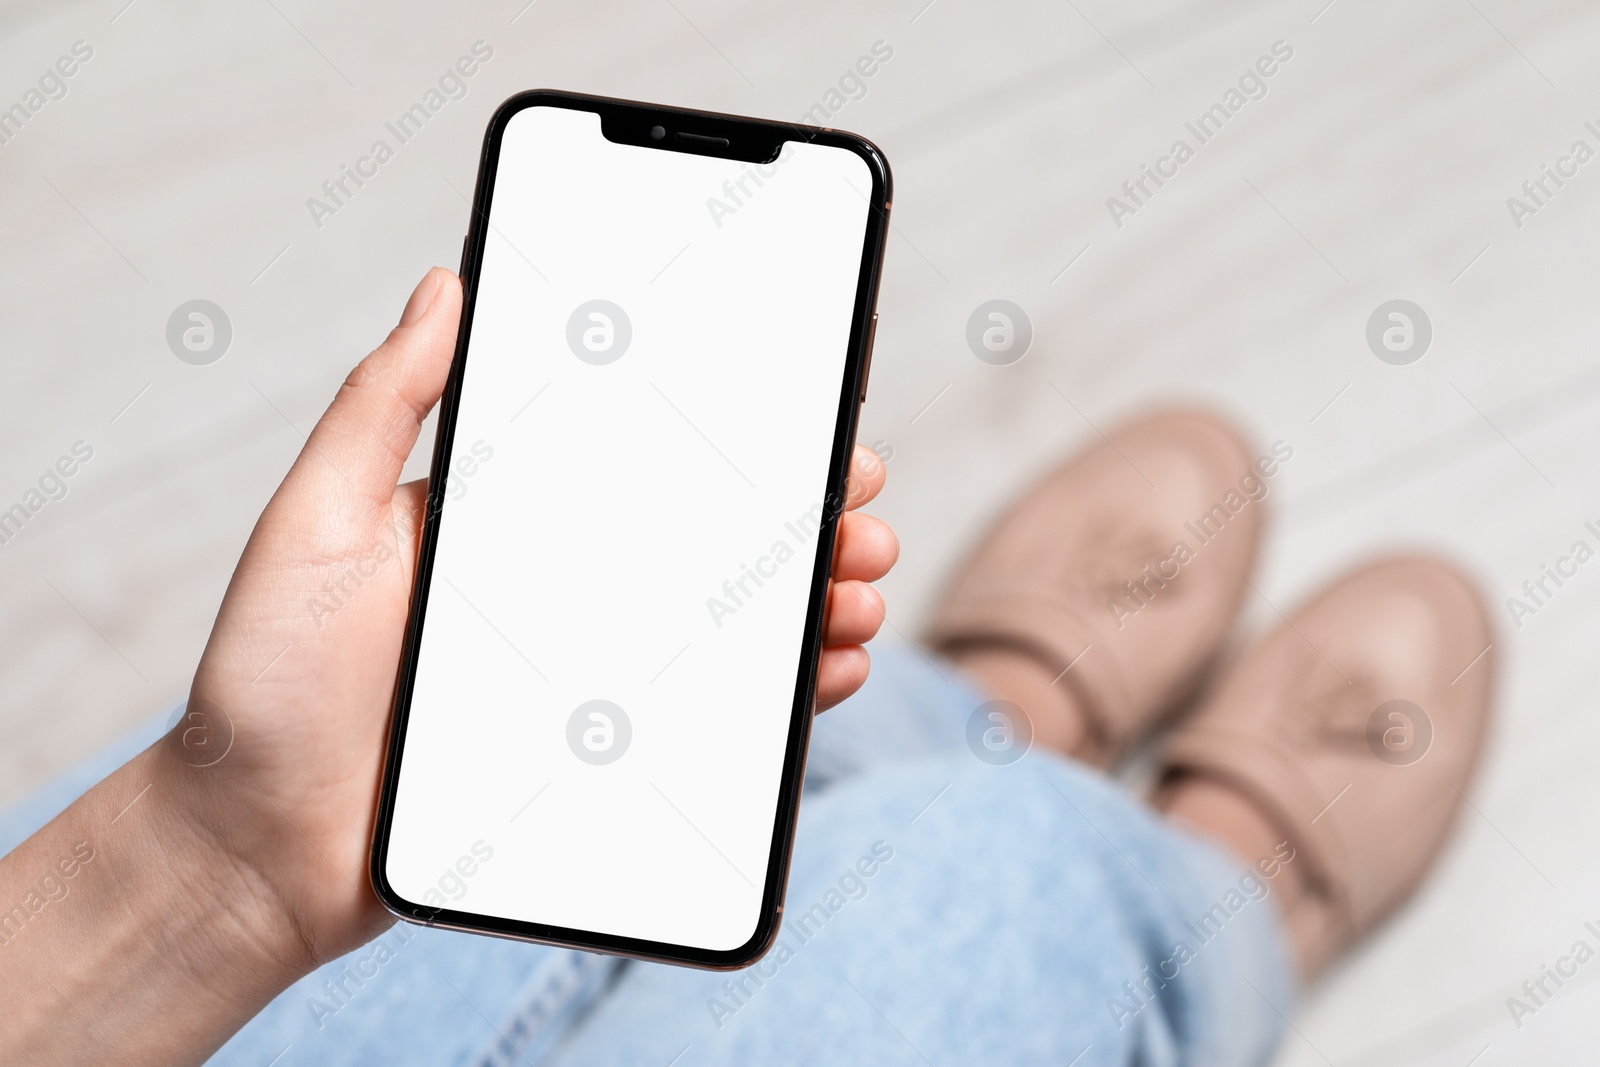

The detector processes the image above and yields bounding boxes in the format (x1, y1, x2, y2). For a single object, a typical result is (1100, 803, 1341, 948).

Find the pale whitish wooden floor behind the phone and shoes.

(0, 0, 1600, 1067)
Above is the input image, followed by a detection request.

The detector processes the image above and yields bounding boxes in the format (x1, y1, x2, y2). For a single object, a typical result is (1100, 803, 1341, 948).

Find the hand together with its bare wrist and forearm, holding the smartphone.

(0, 267, 898, 1062)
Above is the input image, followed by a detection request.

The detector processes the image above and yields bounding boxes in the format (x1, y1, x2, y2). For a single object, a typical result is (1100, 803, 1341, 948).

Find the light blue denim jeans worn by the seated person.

(0, 641, 1293, 1067)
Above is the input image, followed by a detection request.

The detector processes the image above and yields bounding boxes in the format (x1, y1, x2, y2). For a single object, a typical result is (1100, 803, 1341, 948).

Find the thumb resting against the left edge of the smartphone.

(291, 267, 461, 504)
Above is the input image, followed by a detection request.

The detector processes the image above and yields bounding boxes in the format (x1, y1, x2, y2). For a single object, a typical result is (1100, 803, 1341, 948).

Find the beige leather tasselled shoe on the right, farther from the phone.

(1157, 557, 1494, 976)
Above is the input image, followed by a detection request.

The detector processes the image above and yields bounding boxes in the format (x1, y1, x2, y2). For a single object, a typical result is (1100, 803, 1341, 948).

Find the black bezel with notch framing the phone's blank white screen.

(370, 90, 893, 969)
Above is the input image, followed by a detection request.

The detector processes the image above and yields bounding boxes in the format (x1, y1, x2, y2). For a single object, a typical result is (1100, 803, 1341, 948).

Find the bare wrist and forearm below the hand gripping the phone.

(0, 742, 314, 1064)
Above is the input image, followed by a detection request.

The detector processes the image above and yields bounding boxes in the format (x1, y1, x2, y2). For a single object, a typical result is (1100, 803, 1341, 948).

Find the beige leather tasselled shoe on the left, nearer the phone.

(926, 411, 1273, 766)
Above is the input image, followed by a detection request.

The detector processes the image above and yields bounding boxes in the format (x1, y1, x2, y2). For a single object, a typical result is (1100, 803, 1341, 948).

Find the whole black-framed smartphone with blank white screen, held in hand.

(371, 91, 891, 968)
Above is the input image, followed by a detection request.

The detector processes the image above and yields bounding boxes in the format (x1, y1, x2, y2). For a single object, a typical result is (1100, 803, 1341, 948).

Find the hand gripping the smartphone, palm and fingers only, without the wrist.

(174, 267, 898, 961)
